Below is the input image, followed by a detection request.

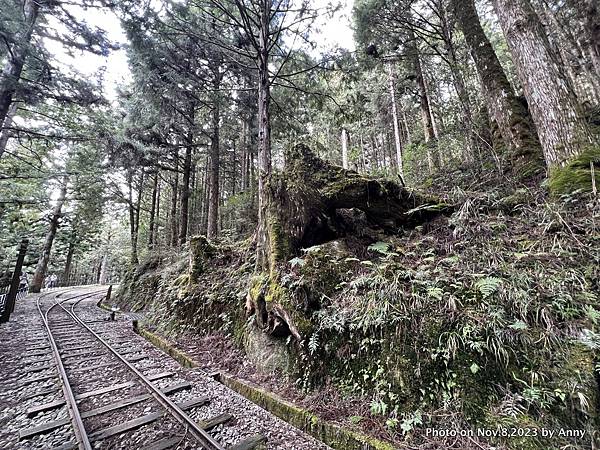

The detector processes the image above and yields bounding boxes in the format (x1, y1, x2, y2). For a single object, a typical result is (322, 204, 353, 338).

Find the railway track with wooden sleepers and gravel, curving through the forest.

(19, 289, 265, 450)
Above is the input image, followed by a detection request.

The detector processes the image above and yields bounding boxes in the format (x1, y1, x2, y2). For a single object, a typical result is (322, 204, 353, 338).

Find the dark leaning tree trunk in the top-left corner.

(0, 0, 41, 132)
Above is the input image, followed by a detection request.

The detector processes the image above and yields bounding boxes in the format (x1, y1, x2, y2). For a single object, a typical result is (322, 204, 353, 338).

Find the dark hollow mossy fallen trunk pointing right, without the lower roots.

(267, 144, 451, 268)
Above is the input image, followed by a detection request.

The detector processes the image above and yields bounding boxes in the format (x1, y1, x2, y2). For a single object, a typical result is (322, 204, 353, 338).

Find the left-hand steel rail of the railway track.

(37, 289, 106, 450)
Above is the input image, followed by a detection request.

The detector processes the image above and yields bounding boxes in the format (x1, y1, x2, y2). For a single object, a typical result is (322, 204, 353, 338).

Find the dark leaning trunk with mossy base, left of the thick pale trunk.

(451, 0, 543, 177)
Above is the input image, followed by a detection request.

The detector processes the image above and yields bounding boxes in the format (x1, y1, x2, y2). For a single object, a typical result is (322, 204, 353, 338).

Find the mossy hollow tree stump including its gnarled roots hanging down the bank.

(246, 144, 451, 342)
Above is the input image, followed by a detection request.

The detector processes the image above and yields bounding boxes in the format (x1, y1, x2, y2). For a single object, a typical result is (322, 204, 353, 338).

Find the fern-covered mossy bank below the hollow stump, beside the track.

(115, 163, 600, 449)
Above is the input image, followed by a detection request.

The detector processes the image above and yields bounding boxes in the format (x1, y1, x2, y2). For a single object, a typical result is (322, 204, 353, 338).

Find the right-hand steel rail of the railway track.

(60, 299, 225, 450)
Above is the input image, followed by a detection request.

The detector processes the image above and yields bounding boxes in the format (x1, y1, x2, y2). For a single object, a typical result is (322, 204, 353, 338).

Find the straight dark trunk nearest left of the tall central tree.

(206, 75, 223, 239)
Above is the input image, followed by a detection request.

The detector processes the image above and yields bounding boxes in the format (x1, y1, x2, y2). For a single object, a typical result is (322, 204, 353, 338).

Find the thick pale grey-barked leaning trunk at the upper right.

(494, 0, 592, 168)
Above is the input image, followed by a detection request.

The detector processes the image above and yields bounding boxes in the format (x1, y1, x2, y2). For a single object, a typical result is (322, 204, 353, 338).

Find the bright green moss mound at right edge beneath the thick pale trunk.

(548, 146, 600, 195)
